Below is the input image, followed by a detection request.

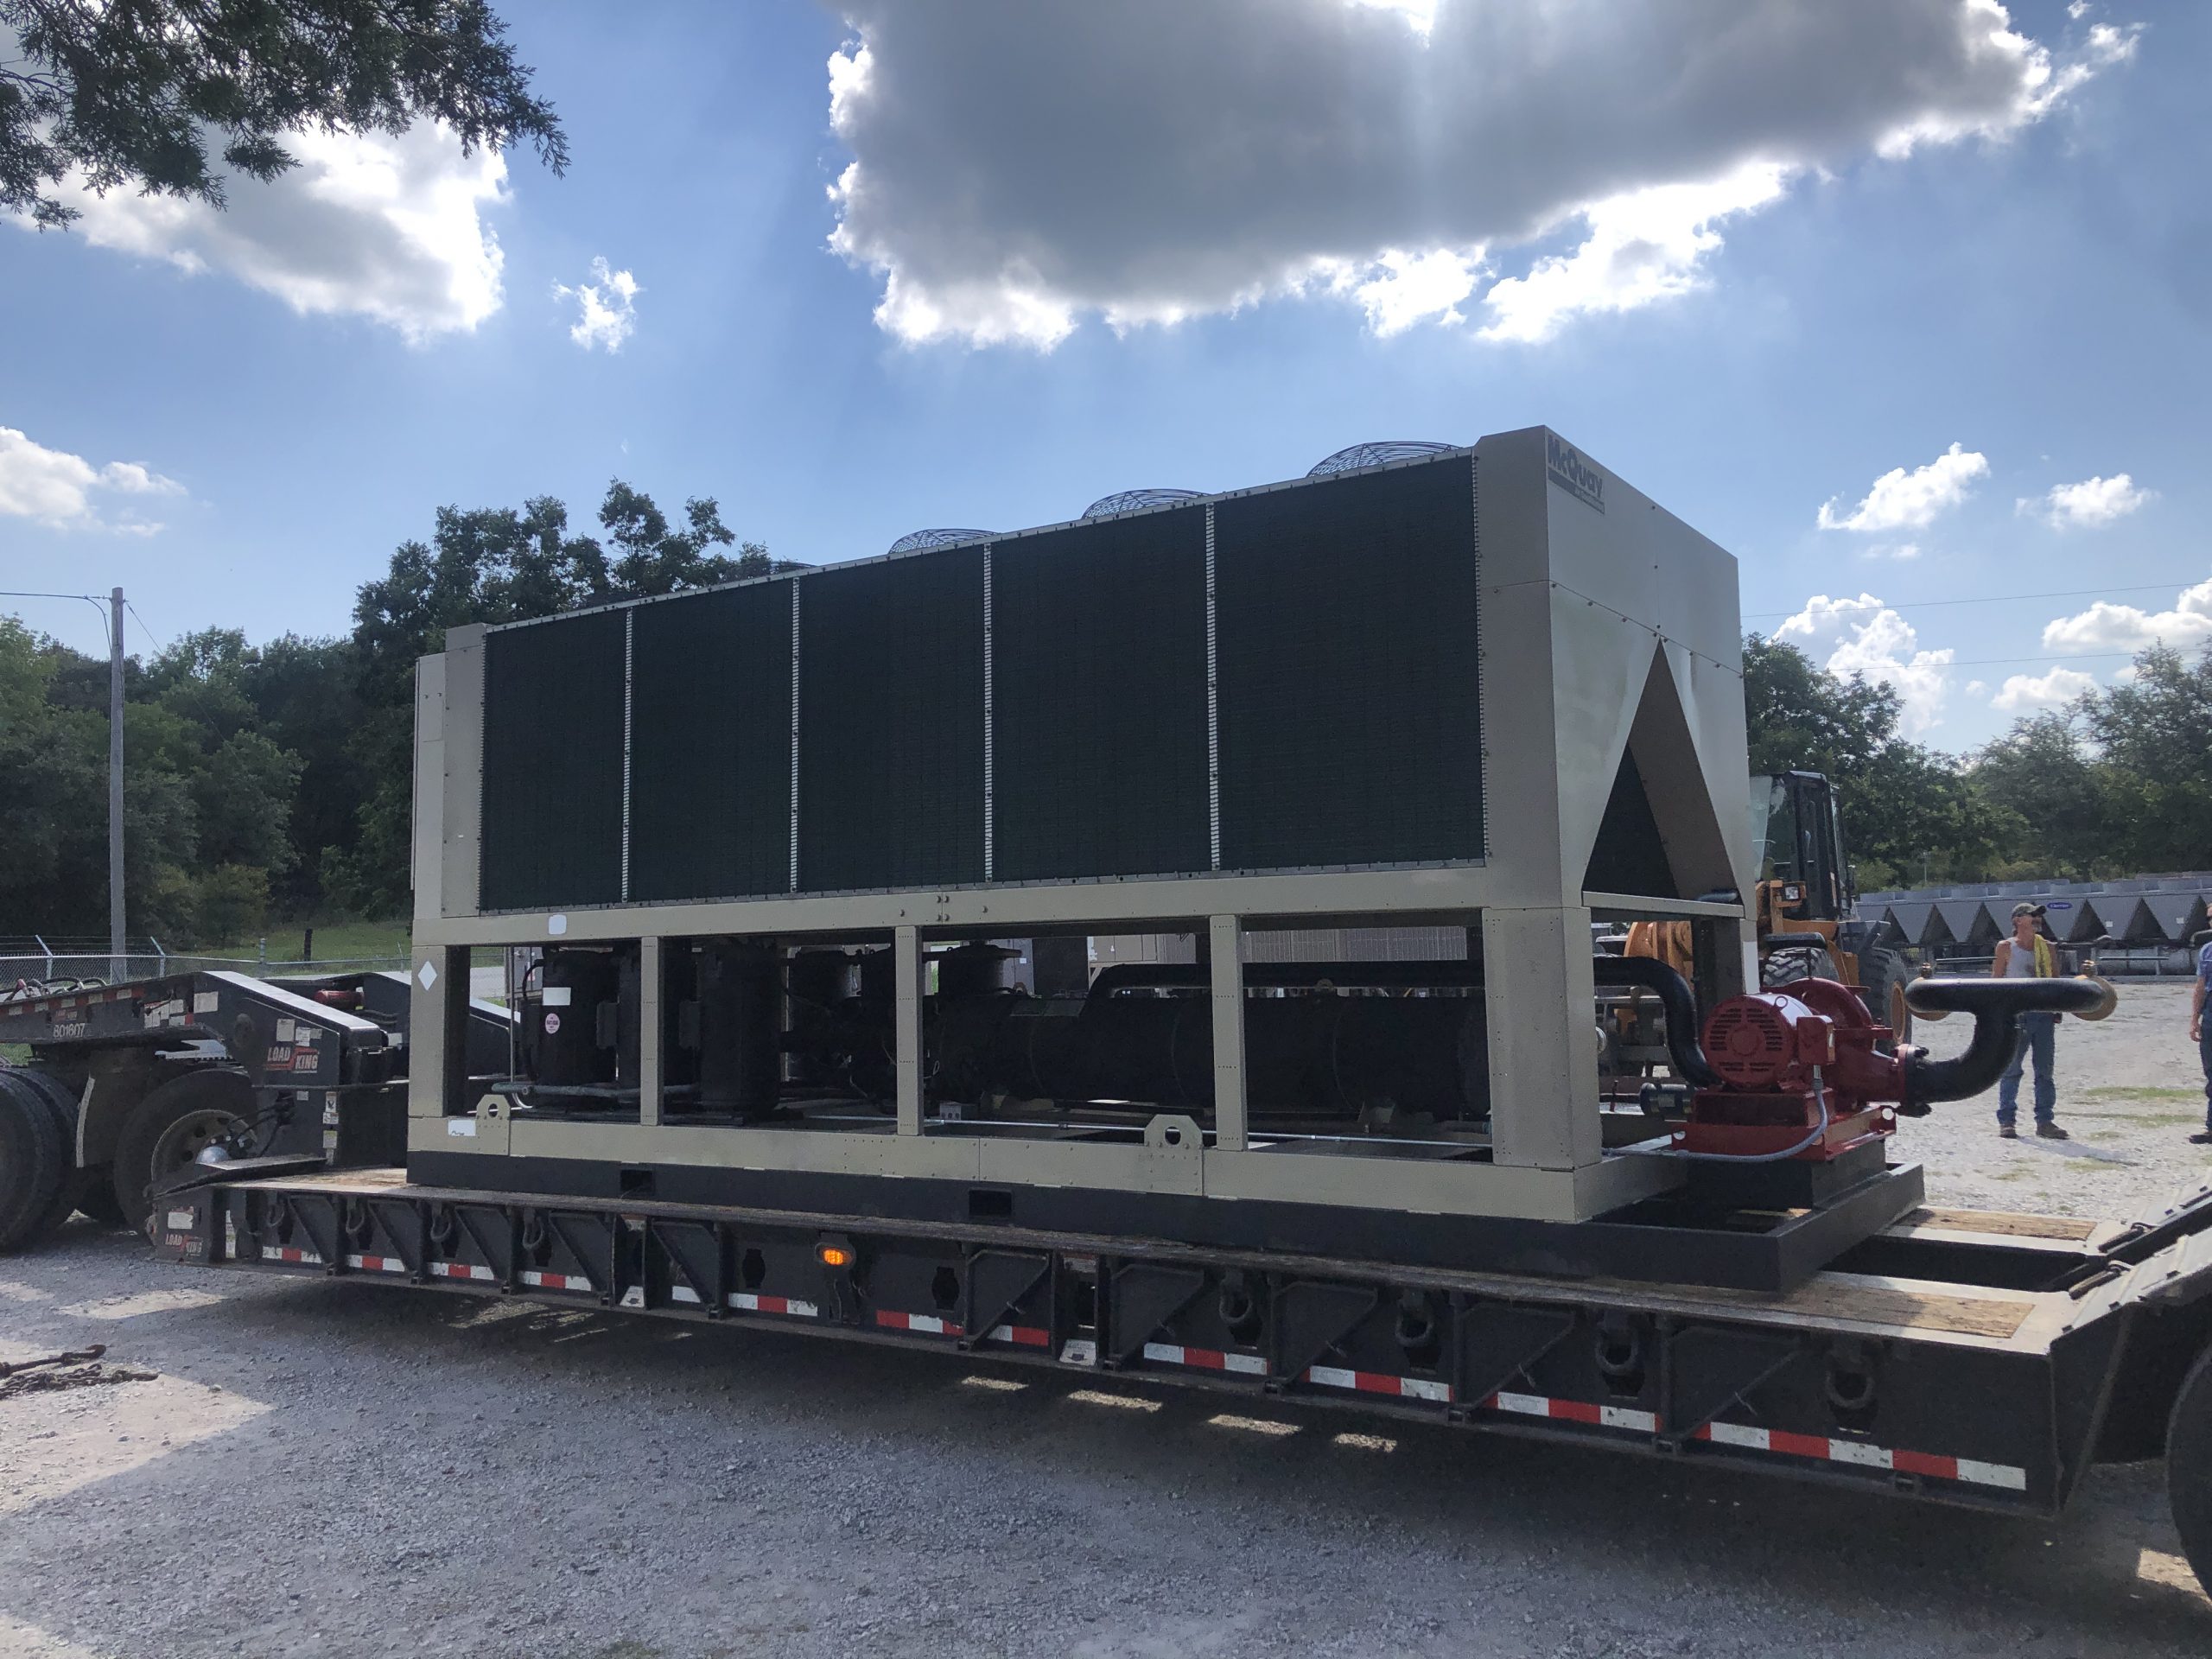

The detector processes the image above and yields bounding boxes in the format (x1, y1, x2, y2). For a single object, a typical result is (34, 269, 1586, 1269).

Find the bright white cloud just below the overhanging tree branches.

(17, 122, 506, 343)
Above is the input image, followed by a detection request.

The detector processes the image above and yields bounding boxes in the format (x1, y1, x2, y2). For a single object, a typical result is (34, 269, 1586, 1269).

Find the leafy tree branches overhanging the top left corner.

(0, 0, 569, 228)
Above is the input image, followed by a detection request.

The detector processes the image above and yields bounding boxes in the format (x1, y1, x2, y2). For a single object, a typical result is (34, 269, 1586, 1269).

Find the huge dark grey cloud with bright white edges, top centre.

(830, 0, 2133, 349)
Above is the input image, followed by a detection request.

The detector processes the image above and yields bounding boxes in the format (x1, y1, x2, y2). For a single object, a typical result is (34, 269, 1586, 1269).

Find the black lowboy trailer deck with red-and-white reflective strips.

(155, 1168, 2212, 1539)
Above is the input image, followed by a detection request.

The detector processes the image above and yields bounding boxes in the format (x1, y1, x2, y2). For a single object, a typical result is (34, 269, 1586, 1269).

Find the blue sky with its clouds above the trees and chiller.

(0, 0, 2212, 750)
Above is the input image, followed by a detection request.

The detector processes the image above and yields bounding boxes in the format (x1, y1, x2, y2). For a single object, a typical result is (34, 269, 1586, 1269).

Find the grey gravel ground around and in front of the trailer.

(0, 987, 2212, 1659)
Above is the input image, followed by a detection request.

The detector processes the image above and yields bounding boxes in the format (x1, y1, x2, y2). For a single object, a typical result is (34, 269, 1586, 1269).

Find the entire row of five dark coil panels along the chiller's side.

(478, 451, 1484, 912)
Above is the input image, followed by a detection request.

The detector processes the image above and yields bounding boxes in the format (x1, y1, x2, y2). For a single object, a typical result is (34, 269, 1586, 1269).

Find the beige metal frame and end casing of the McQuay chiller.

(410, 427, 1752, 1221)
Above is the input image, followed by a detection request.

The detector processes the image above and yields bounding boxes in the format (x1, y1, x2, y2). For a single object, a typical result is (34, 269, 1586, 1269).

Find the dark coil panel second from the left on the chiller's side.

(626, 582, 791, 902)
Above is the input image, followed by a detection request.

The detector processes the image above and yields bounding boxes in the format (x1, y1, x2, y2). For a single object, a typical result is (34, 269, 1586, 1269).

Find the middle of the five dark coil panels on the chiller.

(798, 546, 984, 892)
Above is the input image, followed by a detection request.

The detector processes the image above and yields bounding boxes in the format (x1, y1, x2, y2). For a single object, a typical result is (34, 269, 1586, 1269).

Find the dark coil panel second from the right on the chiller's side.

(991, 506, 1210, 880)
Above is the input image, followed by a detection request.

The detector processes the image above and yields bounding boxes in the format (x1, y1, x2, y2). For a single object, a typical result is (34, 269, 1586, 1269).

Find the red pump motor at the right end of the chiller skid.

(1675, 980, 1904, 1164)
